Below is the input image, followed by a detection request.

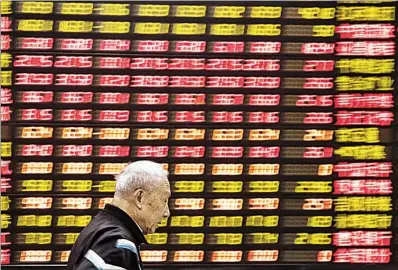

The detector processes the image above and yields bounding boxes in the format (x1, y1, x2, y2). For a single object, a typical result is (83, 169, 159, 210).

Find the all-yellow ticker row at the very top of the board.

(8, 1, 395, 21)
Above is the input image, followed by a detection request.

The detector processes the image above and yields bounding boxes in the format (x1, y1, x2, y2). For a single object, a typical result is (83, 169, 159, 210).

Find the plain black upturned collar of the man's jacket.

(103, 204, 148, 245)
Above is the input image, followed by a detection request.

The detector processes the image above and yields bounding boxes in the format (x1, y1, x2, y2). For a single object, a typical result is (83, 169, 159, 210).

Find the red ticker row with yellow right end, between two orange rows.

(1, 142, 392, 163)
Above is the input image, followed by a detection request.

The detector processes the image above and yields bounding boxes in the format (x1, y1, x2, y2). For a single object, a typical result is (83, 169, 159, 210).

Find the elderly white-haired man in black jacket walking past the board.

(67, 161, 171, 270)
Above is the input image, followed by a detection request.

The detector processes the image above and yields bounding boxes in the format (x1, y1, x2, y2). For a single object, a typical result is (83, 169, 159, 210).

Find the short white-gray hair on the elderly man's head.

(115, 160, 168, 197)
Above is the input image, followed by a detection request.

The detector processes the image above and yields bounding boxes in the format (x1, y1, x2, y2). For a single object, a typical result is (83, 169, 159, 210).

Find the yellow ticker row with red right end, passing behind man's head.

(1, 177, 393, 194)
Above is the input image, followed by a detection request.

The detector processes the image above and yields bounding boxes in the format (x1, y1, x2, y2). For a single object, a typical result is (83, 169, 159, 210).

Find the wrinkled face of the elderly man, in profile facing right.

(142, 178, 171, 234)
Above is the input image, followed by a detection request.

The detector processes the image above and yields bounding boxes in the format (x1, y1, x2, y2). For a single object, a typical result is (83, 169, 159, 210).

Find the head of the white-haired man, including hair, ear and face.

(114, 161, 171, 234)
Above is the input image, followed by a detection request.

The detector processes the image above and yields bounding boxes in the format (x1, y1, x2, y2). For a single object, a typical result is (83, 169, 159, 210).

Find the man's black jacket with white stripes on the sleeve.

(67, 204, 148, 270)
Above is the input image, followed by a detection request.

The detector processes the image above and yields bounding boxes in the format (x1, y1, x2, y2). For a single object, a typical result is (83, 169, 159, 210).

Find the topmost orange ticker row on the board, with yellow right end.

(2, 127, 394, 143)
